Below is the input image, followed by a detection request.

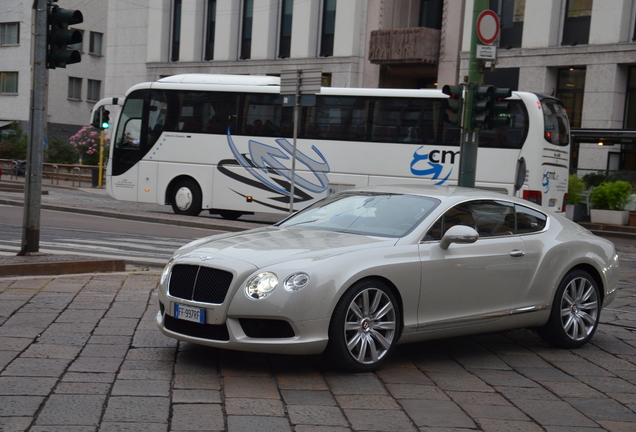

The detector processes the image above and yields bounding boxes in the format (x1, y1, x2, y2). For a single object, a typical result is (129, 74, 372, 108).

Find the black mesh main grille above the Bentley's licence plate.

(168, 264, 232, 304)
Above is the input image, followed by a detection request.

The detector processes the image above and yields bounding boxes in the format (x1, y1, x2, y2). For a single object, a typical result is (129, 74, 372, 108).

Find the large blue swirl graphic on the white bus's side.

(227, 128, 330, 196)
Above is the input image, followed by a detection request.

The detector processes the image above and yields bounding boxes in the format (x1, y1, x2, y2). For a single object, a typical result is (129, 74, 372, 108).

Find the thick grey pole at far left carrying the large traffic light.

(18, 0, 49, 255)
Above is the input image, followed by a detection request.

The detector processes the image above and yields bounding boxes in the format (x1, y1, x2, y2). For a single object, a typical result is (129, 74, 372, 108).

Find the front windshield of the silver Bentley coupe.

(278, 192, 439, 238)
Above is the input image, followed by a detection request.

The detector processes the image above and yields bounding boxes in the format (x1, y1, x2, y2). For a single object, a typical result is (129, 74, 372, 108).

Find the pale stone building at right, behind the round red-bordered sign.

(460, 0, 636, 180)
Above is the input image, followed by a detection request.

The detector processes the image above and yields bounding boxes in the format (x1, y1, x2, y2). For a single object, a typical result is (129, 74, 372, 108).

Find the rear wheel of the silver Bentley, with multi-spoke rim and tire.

(538, 270, 601, 348)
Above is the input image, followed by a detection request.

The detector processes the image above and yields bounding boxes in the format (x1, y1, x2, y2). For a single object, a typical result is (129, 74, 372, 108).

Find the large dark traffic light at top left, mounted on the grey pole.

(46, 4, 84, 69)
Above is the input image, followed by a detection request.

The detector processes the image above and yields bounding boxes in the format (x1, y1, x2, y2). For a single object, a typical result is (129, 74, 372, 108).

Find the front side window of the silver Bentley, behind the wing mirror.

(424, 200, 515, 241)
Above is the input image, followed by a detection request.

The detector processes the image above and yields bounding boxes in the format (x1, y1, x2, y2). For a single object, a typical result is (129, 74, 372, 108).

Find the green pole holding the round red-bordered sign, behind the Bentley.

(458, 0, 489, 188)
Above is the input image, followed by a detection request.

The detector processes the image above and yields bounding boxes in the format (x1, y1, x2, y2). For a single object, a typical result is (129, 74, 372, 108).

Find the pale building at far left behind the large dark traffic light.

(0, 0, 108, 138)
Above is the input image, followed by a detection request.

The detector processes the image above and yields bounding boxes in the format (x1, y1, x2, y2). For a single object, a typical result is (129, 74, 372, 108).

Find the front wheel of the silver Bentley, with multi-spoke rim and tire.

(327, 280, 401, 372)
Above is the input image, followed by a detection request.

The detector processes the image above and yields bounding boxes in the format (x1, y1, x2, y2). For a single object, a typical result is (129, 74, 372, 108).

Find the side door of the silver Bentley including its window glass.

(418, 200, 530, 331)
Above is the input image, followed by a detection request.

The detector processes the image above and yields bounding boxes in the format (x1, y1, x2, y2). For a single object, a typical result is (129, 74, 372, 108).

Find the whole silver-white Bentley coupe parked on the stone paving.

(157, 186, 619, 371)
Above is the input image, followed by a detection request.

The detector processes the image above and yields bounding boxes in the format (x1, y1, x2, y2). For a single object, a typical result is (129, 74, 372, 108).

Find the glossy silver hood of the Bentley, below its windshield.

(175, 227, 396, 268)
